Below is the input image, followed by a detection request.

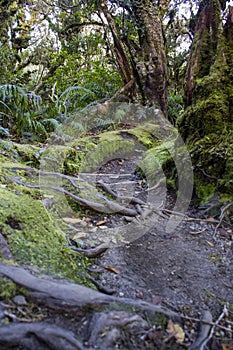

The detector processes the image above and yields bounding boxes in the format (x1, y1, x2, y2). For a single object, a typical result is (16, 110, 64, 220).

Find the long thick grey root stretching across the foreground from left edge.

(0, 263, 180, 319)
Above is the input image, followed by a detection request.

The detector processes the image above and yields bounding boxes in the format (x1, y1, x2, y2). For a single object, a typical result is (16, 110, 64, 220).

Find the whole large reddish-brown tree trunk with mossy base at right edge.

(178, 0, 233, 202)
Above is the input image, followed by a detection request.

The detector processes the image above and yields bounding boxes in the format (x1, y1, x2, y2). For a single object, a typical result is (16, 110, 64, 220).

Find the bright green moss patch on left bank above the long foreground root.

(0, 188, 87, 282)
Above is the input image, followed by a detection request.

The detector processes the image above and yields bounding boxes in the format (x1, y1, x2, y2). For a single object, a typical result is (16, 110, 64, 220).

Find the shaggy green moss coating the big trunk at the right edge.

(177, 18, 233, 203)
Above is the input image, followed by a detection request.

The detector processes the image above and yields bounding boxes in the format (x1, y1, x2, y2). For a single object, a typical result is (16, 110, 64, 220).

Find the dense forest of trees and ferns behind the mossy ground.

(0, 0, 233, 202)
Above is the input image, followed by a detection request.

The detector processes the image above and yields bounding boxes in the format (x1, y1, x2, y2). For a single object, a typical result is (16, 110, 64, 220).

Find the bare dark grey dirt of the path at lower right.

(86, 160, 233, 315)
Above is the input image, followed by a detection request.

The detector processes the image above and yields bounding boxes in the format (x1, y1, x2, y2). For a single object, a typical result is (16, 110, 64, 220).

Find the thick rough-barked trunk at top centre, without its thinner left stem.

(131, 0, 167, 116)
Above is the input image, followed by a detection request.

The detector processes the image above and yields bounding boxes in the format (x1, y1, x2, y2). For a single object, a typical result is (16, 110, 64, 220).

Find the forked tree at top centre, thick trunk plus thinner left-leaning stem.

(100, 0, 167, 116)
